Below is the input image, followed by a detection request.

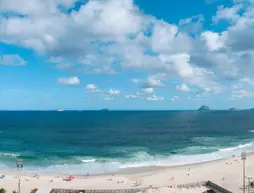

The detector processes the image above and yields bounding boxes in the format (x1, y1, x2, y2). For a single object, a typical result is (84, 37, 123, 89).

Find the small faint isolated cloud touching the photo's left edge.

(0, 55, 27, 66)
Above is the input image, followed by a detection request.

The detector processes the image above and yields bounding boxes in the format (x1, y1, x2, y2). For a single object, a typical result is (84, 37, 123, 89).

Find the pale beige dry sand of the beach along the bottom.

(0, 155, 250, 193)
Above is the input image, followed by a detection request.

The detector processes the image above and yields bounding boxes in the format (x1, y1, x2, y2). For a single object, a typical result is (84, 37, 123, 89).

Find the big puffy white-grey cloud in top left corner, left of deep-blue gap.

(0, 0, 145, 57)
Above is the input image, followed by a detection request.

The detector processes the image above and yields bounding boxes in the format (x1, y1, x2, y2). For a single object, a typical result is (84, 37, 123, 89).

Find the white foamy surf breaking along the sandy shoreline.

(0, 142, 254, 174)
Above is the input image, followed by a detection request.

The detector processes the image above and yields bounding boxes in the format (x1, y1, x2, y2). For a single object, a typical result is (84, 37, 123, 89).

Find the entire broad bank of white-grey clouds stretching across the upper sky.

(0, 0, 254, 98)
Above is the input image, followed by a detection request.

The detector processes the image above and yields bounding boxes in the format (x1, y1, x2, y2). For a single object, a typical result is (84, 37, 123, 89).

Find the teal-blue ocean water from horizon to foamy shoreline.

(0, 111, 254, 174)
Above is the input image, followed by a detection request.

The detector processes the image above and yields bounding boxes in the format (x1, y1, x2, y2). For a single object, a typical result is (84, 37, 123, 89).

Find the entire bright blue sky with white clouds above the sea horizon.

(0, 0, 254, 110)
